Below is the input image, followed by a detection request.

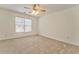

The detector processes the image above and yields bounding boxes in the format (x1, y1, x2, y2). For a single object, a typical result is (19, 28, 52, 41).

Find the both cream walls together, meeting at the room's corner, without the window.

(0, 6, 79, 46)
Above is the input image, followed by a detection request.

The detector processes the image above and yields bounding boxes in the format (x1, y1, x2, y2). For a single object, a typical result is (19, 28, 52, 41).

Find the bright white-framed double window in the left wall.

(16, 17, 32, 32)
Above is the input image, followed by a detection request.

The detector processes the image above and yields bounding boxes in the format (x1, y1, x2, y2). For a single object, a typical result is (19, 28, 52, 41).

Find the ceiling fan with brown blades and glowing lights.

(24, 4, 46, 15)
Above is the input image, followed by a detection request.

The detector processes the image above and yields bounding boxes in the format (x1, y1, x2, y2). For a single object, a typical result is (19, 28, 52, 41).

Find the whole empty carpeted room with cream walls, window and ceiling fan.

(0, 4, 79, 54)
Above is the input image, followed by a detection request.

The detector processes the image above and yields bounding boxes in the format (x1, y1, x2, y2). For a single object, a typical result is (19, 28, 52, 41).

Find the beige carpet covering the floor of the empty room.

(0, 36, 79, 54)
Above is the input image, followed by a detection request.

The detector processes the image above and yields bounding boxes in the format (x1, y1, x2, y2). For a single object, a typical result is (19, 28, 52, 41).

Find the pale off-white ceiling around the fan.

(0, 4, 76, 16)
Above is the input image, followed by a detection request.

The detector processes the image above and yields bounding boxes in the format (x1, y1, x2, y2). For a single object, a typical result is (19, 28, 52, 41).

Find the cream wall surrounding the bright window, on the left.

(0, 8, 38, 40)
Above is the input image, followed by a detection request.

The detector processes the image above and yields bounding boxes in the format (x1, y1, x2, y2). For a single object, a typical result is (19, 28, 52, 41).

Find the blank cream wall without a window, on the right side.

(39, 6, 79, 46)
